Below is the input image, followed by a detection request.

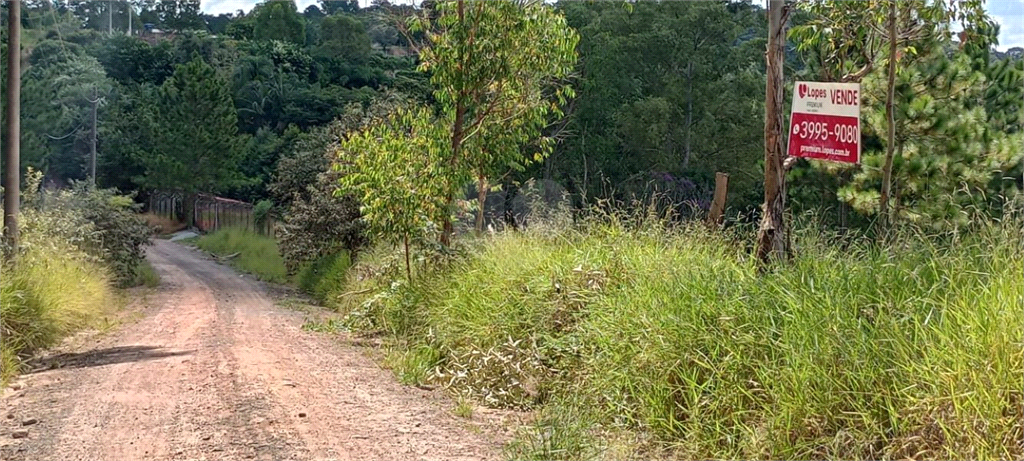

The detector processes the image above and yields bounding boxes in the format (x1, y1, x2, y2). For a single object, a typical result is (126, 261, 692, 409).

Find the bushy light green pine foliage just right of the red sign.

(839, 52, 1024, 227)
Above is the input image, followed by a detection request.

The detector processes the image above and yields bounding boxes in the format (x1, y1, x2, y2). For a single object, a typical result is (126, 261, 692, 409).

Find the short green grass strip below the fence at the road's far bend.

(196, 227, 287, 283)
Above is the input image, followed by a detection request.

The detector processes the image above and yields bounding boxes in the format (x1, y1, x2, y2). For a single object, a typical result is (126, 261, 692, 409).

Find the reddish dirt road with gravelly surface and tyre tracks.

(0, 241, 500, 461)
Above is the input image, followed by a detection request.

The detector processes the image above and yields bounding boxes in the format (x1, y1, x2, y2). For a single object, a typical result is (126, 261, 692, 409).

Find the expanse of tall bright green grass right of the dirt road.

(341, 222, 1024, 459)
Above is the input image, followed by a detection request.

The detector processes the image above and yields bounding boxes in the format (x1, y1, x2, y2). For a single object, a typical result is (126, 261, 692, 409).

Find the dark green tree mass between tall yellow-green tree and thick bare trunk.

(548, 1, 767, 210)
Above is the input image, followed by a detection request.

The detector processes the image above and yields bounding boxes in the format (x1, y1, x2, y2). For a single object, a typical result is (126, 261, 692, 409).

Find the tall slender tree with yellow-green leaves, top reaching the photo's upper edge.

(414, 0, 580, 237)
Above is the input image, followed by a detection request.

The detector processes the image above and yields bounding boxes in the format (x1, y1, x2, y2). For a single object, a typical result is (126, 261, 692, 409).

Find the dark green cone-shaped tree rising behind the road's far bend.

(143, 55, 242, 221)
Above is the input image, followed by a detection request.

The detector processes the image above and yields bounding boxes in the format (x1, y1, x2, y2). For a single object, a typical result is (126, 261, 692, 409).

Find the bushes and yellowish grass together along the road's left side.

(0, 170, 152, 383)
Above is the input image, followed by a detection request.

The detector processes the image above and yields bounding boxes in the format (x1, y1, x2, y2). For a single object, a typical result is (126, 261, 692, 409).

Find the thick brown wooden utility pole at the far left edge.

(3, 0, 22, 249)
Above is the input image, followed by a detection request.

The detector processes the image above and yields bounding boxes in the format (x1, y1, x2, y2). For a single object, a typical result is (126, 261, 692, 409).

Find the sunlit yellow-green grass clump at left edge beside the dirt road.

(0, 241, 117, 383)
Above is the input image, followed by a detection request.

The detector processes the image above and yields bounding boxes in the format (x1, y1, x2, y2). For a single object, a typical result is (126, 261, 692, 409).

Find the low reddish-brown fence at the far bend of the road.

(150, 192, 276, 236)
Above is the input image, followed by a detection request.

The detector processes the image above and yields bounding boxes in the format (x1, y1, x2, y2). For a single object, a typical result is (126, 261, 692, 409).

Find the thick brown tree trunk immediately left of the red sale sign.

(757, 0, 790, 263)
